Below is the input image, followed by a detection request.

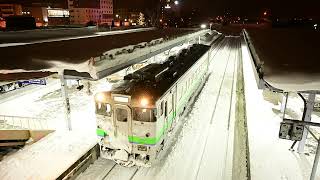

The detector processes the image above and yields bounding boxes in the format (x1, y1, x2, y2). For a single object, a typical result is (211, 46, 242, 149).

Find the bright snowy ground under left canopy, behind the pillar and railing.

(0, 79, 95, 131)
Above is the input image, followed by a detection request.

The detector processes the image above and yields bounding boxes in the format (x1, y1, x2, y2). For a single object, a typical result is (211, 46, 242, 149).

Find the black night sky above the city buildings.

(0, 0, 320, 17)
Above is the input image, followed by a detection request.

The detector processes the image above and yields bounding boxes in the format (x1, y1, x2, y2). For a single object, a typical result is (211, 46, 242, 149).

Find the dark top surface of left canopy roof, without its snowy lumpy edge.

(0, 29, 195, 80)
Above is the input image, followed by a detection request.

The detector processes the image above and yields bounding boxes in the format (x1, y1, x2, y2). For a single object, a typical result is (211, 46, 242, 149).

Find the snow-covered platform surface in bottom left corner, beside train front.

(0, 131, 97, 180)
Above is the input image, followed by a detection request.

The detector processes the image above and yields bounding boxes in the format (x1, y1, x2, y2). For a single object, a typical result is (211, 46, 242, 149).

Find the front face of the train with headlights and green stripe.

(95, 89, 157, 165)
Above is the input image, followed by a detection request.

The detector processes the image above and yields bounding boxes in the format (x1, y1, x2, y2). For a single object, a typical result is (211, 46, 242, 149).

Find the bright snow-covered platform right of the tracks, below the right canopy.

(242, 38, 320, 180)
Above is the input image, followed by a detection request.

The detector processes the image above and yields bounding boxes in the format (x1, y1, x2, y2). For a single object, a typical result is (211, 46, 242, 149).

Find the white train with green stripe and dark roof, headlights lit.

(94, 44, 210, 166)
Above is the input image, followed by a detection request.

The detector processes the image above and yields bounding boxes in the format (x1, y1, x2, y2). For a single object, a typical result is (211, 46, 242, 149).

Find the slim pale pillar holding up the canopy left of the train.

(59, 72, 72, 131)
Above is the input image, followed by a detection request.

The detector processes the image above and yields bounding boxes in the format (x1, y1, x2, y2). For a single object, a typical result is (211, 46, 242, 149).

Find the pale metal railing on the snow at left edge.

(0, 115, 49, 130)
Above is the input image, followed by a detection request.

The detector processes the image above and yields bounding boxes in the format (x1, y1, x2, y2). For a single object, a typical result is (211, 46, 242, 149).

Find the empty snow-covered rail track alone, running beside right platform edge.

(192, 39, 238, 179)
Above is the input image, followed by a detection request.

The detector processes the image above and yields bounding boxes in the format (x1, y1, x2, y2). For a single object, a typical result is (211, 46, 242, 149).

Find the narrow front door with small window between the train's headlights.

(114, 104, 132, 152)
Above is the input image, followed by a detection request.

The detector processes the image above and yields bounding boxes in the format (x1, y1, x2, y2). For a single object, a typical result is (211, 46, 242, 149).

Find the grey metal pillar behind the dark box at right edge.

(297, 94, 316, 153)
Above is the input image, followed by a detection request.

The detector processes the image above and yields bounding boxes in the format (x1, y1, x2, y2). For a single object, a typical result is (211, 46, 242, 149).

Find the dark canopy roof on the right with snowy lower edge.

(247, 28, 320, 91)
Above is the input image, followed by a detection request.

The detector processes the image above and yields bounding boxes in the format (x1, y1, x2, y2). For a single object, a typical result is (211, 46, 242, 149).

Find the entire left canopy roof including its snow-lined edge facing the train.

(0, 29, 208, 80)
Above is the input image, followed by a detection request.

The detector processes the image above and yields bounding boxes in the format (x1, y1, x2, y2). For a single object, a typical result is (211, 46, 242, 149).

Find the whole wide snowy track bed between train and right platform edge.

(129, 38, 239, 180)
